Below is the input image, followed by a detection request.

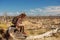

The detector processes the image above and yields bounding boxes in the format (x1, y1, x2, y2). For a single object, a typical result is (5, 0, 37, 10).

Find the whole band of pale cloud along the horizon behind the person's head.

(0, 6, 60, 16)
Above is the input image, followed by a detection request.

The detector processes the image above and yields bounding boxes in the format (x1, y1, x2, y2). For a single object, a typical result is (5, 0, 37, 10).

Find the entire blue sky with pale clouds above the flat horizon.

(0, 0, 60, 16)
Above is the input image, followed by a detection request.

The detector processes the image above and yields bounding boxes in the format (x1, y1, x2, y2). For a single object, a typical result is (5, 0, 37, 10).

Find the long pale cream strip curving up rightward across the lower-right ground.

(25, 28, 59, 40)
